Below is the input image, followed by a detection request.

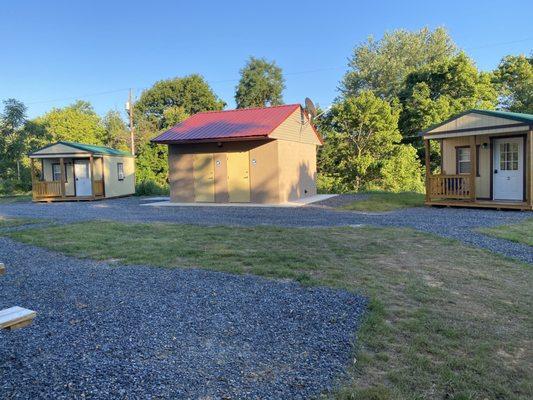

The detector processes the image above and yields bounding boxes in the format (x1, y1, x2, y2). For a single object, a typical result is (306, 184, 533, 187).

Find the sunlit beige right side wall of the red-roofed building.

(276, 140, 316, 202)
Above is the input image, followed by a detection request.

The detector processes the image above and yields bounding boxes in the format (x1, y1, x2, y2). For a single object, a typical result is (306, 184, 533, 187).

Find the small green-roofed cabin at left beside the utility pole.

(30, 142, 135, 201)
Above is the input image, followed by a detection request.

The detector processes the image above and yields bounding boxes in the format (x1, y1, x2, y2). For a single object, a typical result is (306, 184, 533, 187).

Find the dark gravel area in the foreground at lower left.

(0, 238, 366, 399)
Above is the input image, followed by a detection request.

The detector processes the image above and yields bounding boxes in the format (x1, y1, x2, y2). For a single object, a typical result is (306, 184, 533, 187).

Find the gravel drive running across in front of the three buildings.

(0, 195, 533, 263)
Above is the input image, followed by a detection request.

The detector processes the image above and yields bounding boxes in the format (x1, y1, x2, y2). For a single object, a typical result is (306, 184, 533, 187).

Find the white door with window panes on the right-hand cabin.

(492, 137, 524, 201)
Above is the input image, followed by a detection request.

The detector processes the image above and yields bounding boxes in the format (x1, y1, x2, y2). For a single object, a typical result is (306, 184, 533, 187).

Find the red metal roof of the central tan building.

(152, 104, 300, 143)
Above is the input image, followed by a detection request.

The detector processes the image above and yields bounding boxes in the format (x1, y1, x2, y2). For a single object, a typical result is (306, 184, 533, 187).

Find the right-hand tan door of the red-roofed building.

(227, 151, 250, 203)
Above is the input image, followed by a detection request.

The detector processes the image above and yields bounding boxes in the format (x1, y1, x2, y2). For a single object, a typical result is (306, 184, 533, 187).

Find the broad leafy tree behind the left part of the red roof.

(134, 74, 226, 127)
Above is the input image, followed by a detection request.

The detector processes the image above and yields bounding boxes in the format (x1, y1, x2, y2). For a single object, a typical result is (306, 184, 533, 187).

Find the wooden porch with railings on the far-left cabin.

(31, 156, 105, 202)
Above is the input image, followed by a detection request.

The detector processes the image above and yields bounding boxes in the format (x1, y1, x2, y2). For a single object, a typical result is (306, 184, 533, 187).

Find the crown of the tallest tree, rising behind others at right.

(340, 28, 457, 101)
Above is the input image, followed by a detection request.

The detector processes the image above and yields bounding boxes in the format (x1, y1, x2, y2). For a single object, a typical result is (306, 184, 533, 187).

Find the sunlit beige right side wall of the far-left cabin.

(102, 156, 135, 197)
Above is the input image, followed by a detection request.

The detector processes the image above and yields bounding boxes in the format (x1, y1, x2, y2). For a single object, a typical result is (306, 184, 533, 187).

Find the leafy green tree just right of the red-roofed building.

(318, 90, 423, 192)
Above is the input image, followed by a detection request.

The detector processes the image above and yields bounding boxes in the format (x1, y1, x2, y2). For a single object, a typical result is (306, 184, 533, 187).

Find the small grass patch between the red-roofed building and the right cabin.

(341, 192, 424, 212)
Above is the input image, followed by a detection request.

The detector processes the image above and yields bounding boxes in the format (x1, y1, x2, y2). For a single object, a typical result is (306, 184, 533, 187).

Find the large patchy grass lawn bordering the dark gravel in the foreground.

(6, 222, 533, 400)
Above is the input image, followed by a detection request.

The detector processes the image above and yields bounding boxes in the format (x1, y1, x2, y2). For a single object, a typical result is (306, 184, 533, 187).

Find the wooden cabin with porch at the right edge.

(421, 110, 533, 210)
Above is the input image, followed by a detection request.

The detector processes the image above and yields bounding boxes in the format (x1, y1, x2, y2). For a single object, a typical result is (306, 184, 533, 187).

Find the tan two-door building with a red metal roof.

(152, 104, 322, 203)
